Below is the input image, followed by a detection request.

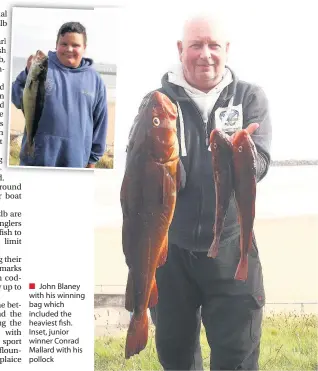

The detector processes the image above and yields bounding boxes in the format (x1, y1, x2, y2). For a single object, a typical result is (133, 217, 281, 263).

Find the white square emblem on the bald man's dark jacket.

(215, 104, 243, 135)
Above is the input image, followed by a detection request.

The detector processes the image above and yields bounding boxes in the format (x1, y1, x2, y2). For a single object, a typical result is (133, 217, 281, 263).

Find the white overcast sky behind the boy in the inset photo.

(12, 7, 122, 64)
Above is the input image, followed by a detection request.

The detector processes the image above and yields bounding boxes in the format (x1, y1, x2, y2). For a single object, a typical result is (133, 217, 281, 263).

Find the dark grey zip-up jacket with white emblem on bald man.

(133, 67, 272, 251)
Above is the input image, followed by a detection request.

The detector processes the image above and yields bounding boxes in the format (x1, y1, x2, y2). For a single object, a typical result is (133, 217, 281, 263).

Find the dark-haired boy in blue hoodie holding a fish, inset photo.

(12, 22, 107, 168)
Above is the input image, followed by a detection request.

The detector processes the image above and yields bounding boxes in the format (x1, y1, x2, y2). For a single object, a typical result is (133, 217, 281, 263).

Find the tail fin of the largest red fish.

(125, 310, 148, 359)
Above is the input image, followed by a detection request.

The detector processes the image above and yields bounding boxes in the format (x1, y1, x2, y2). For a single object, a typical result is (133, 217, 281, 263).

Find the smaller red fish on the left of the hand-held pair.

(208, 129, 233, 258)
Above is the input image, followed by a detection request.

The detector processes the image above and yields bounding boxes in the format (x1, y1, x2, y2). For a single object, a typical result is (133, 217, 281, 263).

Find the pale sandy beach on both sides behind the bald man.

(95, 215, 318, 303)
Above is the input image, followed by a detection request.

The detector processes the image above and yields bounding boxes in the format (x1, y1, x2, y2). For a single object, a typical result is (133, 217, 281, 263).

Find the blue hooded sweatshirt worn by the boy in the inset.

(12, 51, 107, 168)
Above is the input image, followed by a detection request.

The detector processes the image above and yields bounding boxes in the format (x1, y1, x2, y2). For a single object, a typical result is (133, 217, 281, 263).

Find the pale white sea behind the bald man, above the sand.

(95, 165, 318, 228)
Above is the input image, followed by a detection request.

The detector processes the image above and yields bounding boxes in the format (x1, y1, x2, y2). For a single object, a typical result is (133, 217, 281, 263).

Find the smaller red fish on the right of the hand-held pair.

(233, 129, 257, 281)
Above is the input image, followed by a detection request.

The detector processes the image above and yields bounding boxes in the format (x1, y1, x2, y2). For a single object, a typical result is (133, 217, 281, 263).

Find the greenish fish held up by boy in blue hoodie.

(22, 50, 48, 155)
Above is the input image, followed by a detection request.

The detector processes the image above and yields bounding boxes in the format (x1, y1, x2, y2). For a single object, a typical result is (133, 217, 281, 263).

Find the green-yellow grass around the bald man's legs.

(95, 314, 318, 371)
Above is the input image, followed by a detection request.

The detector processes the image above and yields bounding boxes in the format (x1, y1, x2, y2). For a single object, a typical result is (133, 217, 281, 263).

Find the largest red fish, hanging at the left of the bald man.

(120, 91, 180, 359)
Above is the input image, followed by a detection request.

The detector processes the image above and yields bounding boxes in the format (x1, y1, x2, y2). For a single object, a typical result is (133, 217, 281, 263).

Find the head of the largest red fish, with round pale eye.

(148, 91, 179, 163)
